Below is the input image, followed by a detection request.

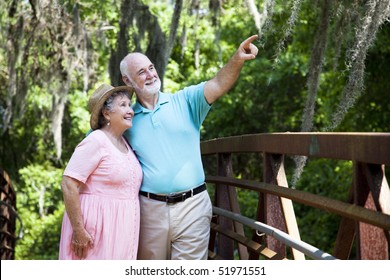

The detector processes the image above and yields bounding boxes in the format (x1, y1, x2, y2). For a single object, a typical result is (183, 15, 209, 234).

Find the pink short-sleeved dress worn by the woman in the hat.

(59, 130, 142, 260)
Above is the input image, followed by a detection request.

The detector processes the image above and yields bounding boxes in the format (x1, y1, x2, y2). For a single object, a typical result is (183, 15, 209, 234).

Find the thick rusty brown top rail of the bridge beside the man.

(201, 132, 390, 165)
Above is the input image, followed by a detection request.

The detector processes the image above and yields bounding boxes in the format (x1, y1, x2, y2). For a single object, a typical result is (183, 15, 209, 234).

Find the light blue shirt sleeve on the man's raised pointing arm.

(183, 82, 212, 127)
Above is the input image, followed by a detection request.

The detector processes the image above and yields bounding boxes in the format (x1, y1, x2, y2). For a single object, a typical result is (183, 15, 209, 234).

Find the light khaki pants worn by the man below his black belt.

(138, 190, 212, 260)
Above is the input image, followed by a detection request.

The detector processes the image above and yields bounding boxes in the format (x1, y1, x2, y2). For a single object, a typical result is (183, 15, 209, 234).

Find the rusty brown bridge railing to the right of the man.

(201, 133, 390, 259)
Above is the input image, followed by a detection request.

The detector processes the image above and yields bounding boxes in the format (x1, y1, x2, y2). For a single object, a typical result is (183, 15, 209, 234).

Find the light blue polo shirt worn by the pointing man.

(124, 82, 211, 194)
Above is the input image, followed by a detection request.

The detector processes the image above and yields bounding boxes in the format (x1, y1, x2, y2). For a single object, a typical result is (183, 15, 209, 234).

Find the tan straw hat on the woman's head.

(88, 84, 134, 130)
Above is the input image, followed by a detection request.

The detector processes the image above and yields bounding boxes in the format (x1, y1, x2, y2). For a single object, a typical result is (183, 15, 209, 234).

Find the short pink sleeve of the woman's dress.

(64, 133, 102, 183)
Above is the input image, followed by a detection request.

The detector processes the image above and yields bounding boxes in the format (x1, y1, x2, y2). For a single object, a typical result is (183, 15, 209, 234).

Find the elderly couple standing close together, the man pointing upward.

(59, 35, 258, 260)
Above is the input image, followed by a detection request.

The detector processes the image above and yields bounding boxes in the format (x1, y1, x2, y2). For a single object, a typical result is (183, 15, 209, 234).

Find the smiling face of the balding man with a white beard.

(125, 53, 161, 97)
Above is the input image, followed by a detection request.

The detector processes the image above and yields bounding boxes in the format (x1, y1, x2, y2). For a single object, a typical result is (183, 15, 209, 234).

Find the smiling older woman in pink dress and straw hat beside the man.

(59, 84, 142, 260)
